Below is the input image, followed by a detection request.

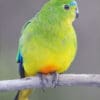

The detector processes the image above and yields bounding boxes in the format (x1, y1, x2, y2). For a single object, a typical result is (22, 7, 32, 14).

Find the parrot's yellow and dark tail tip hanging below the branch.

(14, 89, 32, 100)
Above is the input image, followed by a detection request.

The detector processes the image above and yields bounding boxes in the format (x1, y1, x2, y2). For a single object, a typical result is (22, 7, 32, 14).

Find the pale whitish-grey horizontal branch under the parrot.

(0, 74, 100, 91)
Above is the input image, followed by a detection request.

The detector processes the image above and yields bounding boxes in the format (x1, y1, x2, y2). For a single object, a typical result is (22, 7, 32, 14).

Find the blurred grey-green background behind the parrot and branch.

(0, 0, 100, 100)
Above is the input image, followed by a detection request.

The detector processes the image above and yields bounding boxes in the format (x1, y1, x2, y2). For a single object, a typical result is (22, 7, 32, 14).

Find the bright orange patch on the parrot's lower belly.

(40, 66, 57, 74)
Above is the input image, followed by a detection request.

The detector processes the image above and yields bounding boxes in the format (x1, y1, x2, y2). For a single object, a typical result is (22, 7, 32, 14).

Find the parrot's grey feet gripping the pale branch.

(39, 72, 58, 91)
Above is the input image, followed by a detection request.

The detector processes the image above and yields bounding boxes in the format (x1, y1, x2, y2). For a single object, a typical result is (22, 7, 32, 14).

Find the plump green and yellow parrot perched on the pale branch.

(14, 0, 79, 100)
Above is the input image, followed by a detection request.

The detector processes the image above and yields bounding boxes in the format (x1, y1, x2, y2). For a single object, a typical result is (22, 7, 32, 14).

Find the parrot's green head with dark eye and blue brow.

(40, 0, 79, 23)
